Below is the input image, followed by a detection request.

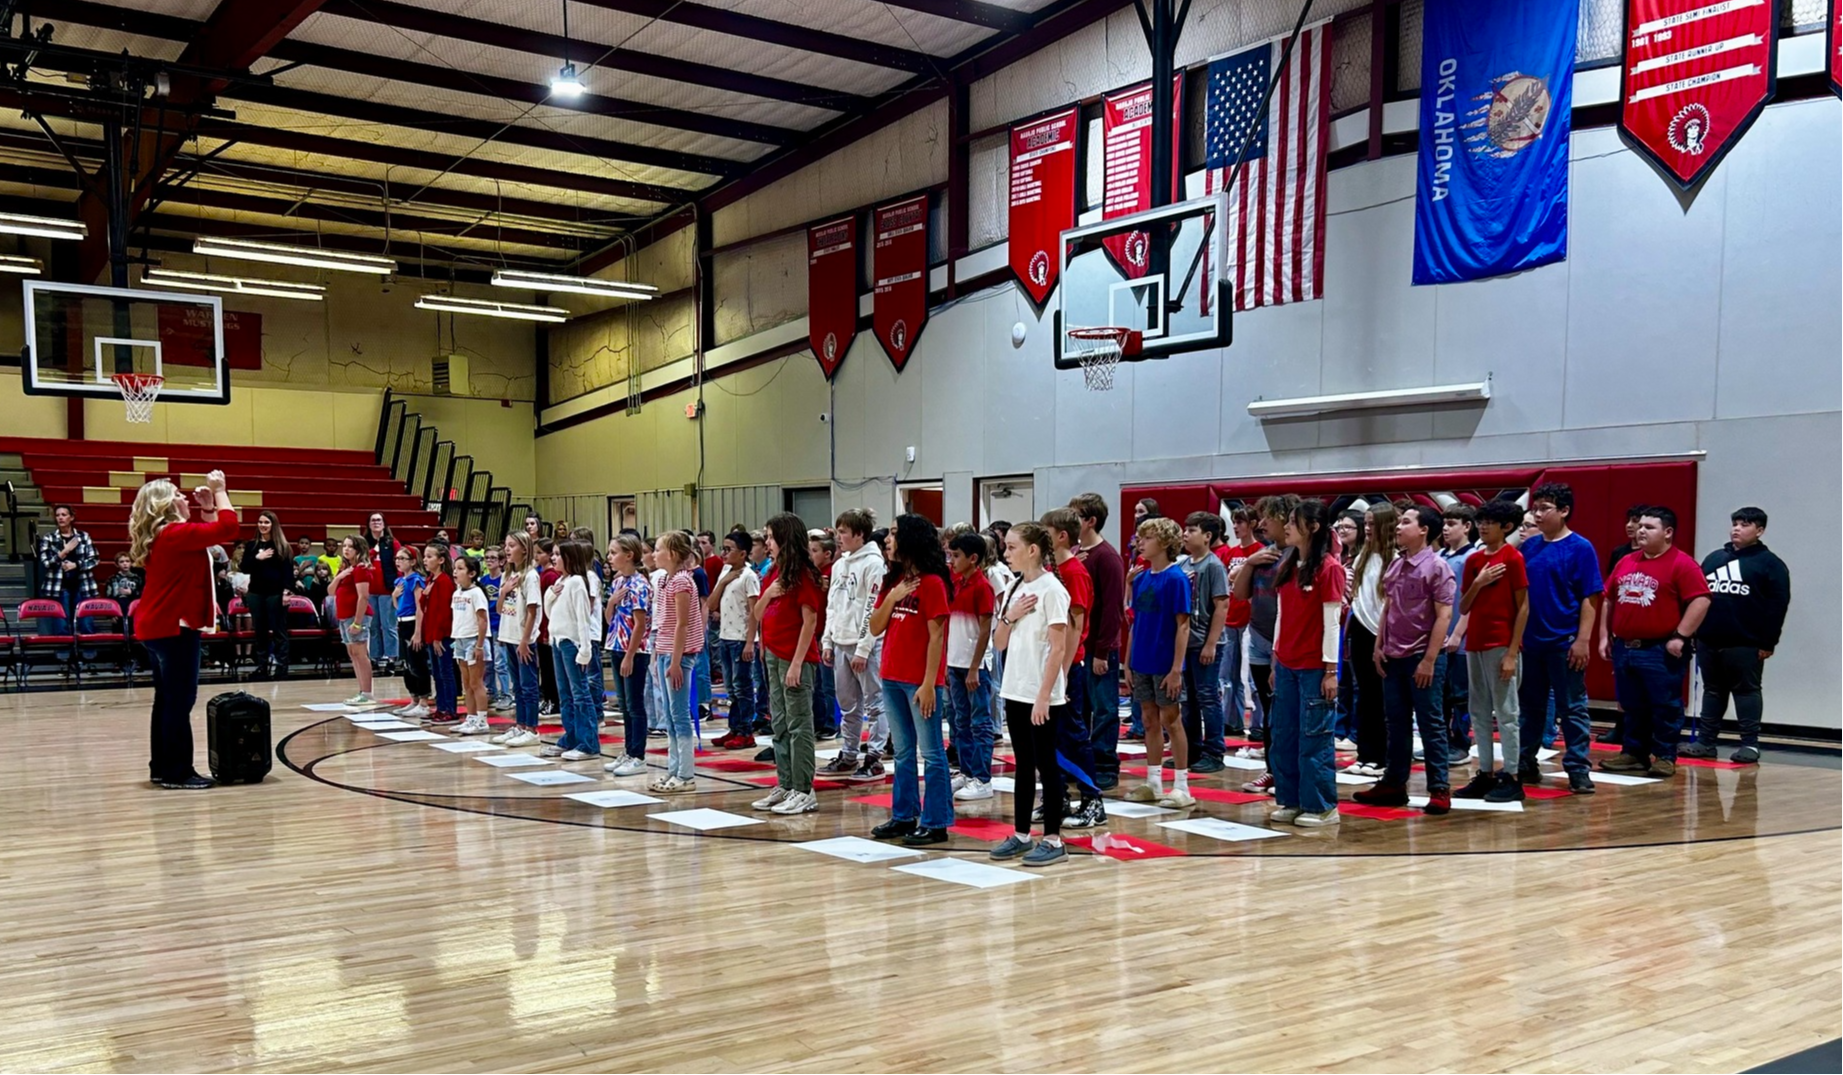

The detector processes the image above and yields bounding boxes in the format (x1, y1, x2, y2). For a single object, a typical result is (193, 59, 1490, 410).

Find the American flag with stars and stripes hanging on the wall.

(1203, 22, 1331, 310)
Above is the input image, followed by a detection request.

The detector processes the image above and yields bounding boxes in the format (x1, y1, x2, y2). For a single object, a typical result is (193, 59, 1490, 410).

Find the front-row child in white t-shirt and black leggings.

(992, 522, 1074, 867)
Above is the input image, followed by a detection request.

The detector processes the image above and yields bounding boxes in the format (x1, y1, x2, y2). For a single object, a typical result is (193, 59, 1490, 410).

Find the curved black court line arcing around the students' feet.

(275, 717, 1843, 861)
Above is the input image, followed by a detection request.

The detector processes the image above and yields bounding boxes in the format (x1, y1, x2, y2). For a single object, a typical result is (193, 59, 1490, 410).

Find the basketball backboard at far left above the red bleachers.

(20, 280, 230, 404)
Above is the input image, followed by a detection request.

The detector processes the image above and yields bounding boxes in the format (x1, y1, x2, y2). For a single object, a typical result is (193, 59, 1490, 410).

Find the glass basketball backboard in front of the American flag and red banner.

(1052, 194, 1233, 369)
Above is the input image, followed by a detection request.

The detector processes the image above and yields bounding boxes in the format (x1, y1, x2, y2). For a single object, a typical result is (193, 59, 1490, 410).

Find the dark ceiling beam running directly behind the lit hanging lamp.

(44, 0, 800, 146)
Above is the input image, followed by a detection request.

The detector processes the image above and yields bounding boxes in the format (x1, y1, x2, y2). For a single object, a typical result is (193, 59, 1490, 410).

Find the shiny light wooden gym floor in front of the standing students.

(0, 680, 1843, 1071)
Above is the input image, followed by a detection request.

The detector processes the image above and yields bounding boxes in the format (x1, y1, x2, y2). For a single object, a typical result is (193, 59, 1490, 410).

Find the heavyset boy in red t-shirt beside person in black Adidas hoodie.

(1600, 507, 1708, 776)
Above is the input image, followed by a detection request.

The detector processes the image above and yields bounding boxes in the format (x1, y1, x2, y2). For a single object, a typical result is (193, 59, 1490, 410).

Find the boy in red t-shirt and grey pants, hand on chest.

(1452, 500, 1530, 802)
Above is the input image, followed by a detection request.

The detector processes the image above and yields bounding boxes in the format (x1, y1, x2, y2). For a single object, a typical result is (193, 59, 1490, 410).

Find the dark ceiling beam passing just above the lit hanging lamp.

(323, 0, 866, 111)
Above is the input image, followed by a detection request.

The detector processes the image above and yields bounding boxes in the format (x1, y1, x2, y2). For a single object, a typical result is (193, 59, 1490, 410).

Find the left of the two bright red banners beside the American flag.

(1010, 109, 1082, 306)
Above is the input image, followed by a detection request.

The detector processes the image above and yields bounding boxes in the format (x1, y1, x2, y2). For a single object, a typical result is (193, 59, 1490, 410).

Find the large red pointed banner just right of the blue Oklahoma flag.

(1618, 0, 1778, 190)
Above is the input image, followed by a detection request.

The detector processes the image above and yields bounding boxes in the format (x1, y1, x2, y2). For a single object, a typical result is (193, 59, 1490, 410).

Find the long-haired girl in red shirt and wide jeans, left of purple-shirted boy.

(1235, 500, 1345, 826)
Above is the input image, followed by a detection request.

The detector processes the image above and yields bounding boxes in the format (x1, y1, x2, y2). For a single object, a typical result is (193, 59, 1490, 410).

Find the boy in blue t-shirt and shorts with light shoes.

(1126, 516, 1196, 809)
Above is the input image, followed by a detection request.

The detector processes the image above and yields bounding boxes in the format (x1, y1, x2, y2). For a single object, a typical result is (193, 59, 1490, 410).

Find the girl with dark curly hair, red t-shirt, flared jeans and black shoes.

(870, 514, 953, 846)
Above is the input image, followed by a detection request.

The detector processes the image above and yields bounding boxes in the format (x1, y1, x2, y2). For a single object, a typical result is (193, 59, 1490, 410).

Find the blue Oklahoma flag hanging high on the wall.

(1414, 0, 1579, 284)
